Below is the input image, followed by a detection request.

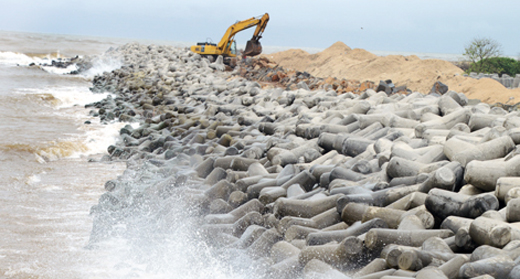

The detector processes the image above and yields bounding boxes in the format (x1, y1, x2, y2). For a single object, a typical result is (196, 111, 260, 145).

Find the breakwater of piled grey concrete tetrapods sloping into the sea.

(90, 44, 520, 278)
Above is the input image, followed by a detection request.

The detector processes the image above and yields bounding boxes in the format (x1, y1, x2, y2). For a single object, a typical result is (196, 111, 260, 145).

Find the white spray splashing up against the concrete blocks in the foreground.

(86, 155, 265, 279)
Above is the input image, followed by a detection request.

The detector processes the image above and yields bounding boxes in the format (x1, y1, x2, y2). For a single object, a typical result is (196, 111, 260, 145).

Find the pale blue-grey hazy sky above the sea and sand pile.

(0, 0, 520, 56)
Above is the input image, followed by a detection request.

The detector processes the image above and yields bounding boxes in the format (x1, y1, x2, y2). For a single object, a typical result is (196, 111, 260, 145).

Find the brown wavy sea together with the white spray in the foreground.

(0, 31, 265, 278)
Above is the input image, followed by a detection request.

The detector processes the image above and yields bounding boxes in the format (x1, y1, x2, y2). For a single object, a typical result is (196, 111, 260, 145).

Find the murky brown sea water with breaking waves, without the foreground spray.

(0, 29, 128, 278)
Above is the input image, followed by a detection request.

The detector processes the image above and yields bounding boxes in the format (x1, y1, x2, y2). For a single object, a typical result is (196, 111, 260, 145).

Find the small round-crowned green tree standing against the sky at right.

(463, 38, 502, 73)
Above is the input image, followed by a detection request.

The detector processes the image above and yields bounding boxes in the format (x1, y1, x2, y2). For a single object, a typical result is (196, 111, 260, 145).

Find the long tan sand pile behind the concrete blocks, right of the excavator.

(266, 42, 520, 103)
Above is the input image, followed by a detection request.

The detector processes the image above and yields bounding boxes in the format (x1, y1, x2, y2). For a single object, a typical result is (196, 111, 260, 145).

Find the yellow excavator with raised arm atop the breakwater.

(190, 13, 269, 61)
